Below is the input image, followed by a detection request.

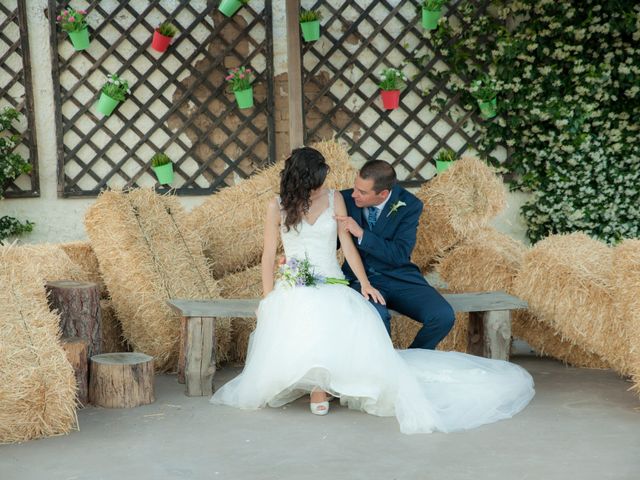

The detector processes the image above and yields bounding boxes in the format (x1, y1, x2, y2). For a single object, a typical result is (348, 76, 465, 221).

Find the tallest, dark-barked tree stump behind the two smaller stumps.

(45, 280, 102, 357)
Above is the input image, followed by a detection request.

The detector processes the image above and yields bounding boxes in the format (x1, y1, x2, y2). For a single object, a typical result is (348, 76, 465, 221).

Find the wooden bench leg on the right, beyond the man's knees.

(467, 310, 511, 360)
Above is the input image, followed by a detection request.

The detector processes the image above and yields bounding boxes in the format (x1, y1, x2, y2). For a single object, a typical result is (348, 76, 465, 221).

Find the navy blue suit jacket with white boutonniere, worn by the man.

(340, 185, 426, 289)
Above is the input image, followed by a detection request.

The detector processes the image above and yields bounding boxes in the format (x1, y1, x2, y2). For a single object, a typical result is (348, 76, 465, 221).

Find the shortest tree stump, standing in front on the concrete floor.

(89, 352, 155, 408)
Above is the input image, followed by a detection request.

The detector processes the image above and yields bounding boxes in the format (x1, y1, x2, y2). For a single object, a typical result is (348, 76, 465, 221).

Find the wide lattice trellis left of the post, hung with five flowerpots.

(49, 0, 275, 197)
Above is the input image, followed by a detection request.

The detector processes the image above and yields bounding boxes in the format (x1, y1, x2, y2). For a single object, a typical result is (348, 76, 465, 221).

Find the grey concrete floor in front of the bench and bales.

(0, 356, 640, 480)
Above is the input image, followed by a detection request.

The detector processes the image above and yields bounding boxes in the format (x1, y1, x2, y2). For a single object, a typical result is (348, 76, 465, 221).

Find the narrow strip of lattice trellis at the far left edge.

(0, 0, 40, 198)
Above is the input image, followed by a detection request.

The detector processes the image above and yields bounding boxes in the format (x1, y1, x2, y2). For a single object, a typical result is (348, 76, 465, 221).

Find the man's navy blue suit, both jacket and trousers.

(341, 185, 455, 349)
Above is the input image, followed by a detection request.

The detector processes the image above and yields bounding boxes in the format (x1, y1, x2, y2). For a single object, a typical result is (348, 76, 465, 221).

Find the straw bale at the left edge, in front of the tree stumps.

(0, 246, 77, 443)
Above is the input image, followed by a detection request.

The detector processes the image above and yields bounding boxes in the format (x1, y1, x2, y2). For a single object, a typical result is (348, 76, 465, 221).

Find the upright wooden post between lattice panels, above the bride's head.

(286, 0, 304, 150)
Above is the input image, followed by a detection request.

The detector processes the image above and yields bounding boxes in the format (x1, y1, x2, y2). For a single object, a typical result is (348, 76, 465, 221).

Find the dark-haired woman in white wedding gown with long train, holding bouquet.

(211, 147, 534, 434)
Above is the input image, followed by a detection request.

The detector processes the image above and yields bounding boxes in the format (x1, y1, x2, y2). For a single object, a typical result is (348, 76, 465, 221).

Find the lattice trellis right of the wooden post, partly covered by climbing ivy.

(302, 0, 500, 186)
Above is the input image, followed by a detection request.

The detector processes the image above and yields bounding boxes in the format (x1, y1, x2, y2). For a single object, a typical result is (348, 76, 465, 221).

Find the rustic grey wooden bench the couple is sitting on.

(168, 292, 527, 396)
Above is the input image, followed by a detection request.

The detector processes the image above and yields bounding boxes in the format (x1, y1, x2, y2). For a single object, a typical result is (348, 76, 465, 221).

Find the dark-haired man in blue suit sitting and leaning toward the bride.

(336, 160, 455, 350)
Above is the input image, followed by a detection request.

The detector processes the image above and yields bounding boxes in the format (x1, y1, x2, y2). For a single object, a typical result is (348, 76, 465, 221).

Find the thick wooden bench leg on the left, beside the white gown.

(178, 317, 216, 397)
